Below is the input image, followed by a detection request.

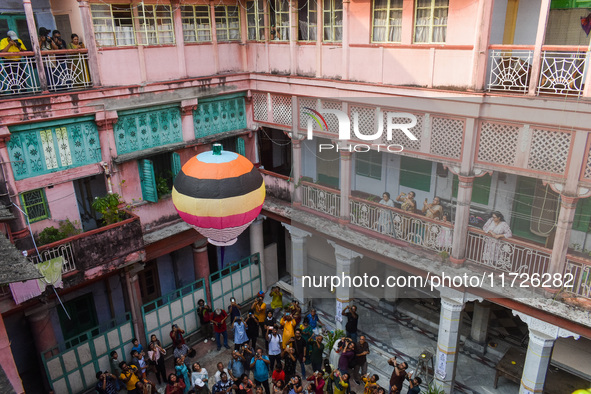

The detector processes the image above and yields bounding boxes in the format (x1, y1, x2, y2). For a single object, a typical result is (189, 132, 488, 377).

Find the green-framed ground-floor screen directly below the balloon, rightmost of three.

(209, 253, 262, 308)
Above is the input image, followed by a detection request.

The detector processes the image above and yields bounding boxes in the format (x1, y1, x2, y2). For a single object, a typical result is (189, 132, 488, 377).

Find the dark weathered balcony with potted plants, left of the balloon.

(27, 213, 144, 286)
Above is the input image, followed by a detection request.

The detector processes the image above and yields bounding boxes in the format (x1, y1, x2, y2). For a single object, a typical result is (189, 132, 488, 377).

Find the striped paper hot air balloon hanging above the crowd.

(172, 144, 265, 246)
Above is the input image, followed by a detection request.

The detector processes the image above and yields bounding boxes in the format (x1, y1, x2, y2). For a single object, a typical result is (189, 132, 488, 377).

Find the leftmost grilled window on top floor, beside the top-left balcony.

(90, 3, 135, 47)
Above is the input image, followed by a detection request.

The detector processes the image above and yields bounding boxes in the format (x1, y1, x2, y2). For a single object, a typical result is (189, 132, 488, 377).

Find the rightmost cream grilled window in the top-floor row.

(414, 0, 449, 43)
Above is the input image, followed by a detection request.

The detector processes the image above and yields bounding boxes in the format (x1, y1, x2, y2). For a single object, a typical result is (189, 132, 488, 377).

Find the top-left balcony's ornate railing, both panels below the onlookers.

(0, 49, 92, 97)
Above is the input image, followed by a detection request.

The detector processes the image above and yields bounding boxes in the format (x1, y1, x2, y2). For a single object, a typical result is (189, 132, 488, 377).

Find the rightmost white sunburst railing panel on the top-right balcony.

(537, 51, 587, 96)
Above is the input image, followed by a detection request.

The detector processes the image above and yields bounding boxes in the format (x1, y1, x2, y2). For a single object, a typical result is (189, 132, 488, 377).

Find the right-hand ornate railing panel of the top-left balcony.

(42, 50, 92, 91)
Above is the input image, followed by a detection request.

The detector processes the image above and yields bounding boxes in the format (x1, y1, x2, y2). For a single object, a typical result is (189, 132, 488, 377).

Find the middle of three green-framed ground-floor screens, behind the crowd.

(142, 279, 205, 346)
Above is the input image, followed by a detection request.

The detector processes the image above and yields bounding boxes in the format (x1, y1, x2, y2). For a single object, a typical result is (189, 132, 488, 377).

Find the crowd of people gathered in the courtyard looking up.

(96, 287, 421, 394)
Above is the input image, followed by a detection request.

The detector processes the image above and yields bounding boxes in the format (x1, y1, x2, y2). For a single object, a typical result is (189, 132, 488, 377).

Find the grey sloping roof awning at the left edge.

(0, 234, 42, 285)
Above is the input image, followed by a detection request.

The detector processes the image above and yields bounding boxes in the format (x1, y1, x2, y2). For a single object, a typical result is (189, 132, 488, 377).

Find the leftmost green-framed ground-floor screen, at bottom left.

(41, 313, 135, 394)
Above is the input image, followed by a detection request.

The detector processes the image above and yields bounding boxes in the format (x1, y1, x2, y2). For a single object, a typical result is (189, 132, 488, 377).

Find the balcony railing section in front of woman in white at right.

(466, 228, 552, 275)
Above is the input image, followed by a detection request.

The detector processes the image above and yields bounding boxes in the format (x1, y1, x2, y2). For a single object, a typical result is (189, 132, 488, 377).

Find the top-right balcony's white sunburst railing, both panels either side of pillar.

(487, 45, 587, 97)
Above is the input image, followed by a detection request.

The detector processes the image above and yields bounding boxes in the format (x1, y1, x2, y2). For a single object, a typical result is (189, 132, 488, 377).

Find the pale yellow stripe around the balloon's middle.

(172, 182, 265, 217)
